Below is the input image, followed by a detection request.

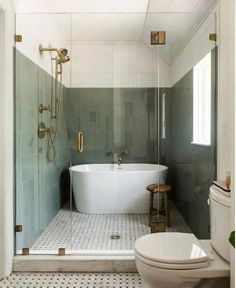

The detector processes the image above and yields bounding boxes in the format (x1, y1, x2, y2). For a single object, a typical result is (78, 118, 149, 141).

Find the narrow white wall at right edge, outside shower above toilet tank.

(218, 0, 236, 288)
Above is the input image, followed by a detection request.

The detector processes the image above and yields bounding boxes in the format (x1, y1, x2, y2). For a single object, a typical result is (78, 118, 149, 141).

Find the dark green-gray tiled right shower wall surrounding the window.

(161, 50, 216, 239)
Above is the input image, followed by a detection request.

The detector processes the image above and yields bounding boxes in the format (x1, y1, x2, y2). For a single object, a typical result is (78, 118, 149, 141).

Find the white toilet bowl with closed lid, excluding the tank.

(135, 232, 229, 288)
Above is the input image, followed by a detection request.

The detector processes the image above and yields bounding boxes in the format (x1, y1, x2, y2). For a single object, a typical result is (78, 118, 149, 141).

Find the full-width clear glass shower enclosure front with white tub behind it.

(15, 5, 217, 255)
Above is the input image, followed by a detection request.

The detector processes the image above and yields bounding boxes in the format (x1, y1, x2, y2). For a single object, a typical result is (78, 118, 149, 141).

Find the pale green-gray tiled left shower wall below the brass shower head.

(15, 50, 70, 251)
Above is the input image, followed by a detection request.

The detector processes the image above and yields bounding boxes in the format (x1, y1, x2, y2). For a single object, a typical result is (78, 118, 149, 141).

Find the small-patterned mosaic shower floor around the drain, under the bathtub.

(31, 202, 191, 251)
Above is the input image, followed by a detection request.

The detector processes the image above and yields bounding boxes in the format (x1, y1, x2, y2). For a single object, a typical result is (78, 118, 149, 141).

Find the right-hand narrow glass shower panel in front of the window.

(150, 9, 217, 239)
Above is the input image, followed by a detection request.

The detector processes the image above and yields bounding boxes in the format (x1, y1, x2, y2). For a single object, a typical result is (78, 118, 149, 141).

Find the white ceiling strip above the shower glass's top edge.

(14, 0, 216, 13)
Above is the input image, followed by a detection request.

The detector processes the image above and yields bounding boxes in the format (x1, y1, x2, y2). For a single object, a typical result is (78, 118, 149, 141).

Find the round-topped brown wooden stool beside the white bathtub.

(146, 184, 171, 226)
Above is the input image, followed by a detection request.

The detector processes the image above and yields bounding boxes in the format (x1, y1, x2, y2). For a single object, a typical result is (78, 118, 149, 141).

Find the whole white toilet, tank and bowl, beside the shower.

(135, 186, 230, 288)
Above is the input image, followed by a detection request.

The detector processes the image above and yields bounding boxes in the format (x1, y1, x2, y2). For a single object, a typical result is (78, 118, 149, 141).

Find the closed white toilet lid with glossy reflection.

(135, 232, 210, 264)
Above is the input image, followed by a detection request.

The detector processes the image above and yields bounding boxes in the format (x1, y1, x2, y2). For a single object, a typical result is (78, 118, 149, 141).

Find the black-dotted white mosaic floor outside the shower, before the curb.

(0, 273, 147, 288)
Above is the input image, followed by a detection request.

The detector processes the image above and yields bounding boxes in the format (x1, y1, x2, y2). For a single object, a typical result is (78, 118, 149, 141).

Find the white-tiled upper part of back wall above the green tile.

(71, 41, 170, 87)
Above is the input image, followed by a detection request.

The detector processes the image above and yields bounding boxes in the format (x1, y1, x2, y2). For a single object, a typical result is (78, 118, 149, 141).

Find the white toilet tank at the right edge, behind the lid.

(209, 186, 230, 261)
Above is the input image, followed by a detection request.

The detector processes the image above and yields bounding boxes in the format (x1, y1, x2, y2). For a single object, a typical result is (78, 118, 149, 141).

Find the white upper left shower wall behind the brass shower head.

(16, 13, 70, 86)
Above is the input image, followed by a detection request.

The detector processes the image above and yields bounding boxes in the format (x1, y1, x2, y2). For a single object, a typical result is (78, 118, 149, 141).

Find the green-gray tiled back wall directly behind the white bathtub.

(64, 88, 168, 165)
